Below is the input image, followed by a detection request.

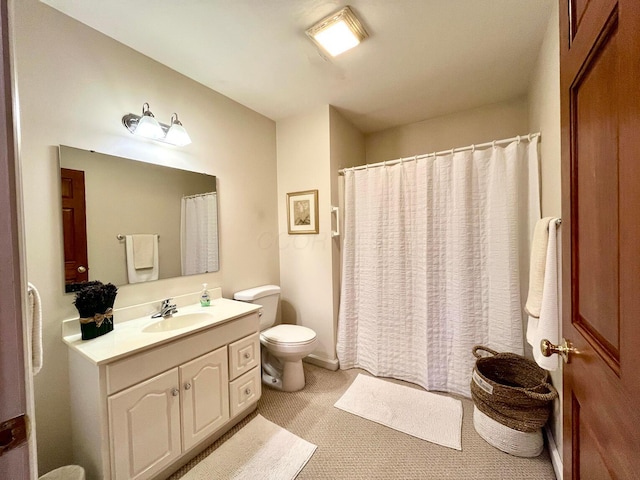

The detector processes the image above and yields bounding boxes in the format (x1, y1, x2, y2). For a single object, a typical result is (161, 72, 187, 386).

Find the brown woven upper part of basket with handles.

(471, 345, 558, 432)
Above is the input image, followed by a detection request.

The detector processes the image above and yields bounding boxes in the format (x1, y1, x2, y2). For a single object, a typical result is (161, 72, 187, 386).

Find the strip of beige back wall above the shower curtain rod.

(365, 97, 529, 163)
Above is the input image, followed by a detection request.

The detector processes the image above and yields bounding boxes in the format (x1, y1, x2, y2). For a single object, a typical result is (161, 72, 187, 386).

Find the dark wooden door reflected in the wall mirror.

(60, 168, 89, 292)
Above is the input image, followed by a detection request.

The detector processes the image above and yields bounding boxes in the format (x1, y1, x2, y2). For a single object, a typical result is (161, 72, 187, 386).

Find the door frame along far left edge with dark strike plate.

(0, 0, 33, 479)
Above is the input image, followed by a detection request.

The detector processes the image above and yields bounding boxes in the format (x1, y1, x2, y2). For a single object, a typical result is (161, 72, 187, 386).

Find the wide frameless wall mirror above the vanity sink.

(59, 145, 219, 292)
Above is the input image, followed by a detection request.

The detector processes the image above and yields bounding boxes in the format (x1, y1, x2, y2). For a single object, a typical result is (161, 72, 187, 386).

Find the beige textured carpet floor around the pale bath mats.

(171, 364, 555, 480)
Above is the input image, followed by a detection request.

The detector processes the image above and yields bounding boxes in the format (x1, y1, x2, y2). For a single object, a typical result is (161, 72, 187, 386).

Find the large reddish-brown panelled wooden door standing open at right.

(560, 0, 640, 480)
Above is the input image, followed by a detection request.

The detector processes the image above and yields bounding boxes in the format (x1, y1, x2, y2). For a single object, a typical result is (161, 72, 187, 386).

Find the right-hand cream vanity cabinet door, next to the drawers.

(180, 346, 229, 451)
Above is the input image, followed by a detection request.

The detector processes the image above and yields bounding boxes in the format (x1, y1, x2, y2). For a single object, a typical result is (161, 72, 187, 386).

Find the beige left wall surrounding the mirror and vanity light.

(10, 0, 278, 474)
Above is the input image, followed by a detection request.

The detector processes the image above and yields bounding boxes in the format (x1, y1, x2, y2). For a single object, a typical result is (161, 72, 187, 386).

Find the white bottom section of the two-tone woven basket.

(473, 405, 544, 457)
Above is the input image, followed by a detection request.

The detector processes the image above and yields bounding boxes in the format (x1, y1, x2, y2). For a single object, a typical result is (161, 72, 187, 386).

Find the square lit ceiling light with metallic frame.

(306, 7, 369, 57)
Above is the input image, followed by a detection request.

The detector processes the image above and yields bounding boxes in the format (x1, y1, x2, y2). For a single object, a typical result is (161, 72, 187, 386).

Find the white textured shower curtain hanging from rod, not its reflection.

(337, 137, 540, 397)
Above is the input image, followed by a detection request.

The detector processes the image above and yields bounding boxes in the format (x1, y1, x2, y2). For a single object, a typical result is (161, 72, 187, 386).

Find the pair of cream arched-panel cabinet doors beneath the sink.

(108, 347, 229, 480)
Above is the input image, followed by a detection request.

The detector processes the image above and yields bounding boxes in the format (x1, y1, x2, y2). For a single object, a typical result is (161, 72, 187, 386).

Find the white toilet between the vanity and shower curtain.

(233, 285, 316, 392)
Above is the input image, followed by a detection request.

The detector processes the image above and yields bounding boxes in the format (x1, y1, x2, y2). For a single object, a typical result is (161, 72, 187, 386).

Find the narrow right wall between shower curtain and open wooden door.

(529, 3, 562, 464)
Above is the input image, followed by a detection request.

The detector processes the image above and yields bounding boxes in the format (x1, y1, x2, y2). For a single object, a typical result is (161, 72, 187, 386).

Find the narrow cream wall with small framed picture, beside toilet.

(276, 105, 335, 360)
